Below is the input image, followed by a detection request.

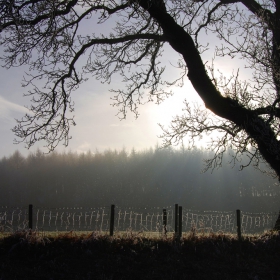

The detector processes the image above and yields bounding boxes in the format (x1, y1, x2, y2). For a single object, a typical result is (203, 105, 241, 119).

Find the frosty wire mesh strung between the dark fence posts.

(0, 206, 278, 234)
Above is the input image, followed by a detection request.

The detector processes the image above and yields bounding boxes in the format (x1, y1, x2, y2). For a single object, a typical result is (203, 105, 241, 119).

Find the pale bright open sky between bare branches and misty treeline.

(0, 49, 206, 158)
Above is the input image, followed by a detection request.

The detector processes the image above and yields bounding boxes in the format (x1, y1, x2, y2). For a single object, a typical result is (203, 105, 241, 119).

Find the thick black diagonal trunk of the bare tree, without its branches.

(139, 0, 280, 179)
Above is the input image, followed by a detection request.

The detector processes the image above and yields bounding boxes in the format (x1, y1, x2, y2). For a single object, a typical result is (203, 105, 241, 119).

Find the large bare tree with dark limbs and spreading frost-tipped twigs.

(0, 0, 280, 179)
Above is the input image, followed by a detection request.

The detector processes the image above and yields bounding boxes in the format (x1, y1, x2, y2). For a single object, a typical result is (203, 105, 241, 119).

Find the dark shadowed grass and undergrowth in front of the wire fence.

(0, 231, 280, 280)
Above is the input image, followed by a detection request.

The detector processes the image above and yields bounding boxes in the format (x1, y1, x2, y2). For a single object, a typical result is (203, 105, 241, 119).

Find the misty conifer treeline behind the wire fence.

(0, 148, 280, 212)
